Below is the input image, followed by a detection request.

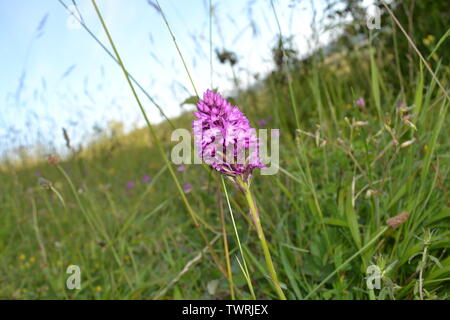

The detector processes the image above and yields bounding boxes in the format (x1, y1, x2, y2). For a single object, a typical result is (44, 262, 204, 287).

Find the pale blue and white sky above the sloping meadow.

(0, 0, 338, 158)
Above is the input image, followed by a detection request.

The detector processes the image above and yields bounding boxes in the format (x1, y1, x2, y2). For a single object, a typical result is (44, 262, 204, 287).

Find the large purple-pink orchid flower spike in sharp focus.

(192, 90, 264, 181)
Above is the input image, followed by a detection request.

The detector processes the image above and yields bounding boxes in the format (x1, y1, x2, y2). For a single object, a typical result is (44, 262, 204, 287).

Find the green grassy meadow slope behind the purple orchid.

(0, 0, 450, 299)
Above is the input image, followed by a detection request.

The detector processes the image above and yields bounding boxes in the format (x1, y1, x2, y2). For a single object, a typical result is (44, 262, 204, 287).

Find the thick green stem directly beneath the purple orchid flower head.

(241, 183, 286, 300)
